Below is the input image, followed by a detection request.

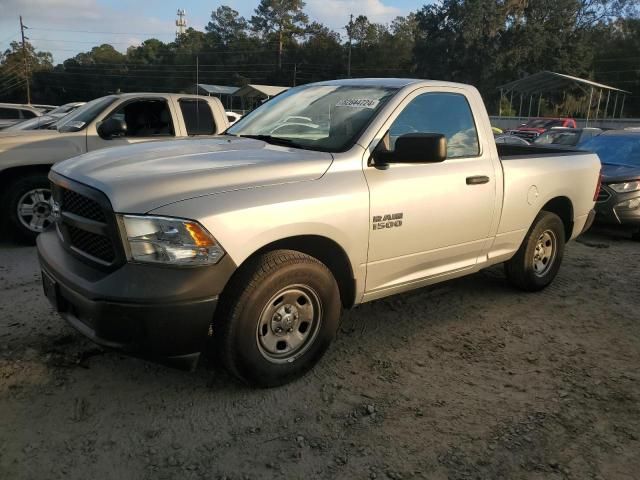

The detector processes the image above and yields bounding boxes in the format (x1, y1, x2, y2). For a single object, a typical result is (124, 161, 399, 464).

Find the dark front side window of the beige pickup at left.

(109, 99, 175, 137)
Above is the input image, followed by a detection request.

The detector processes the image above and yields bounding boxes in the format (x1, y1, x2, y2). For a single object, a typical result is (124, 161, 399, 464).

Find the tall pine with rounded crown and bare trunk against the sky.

(251, 0, 309, 71)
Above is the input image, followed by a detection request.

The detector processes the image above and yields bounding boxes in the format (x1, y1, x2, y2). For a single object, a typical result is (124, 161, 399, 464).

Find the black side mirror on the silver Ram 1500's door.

(374, 133, 447, 169)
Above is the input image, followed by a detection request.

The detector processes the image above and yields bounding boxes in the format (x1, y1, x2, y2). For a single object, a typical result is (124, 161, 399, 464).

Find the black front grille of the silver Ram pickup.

(50, 172, 124, 268)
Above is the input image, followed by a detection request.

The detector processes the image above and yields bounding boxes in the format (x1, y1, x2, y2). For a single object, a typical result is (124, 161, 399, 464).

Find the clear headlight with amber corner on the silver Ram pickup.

(121, 215, 224, 265)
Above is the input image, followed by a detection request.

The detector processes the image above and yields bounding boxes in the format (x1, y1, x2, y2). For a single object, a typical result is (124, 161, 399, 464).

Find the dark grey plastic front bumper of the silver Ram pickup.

(37, 230, 236, 367)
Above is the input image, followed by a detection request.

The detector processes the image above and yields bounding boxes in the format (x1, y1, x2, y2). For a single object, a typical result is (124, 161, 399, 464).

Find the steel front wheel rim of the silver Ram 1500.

(256, 285, 322, 363)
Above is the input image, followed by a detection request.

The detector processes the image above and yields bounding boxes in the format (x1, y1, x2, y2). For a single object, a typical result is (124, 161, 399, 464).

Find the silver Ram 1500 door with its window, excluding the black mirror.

(364, 88, 496, 300)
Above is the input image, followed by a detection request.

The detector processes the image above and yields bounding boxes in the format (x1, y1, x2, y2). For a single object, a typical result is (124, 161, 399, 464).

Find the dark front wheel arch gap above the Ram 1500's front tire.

(223, 234, 356, 308)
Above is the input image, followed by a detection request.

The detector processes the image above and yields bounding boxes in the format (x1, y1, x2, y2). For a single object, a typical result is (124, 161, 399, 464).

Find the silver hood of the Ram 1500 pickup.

(53, 136, 333, 213)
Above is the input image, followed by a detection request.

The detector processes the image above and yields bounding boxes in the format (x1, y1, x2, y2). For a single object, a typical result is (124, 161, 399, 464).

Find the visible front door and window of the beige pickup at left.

(87, 98, 175, 151)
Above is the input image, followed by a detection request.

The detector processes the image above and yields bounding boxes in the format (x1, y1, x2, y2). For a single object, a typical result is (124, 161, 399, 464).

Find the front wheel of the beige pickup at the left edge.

(2, 172, 53, 244)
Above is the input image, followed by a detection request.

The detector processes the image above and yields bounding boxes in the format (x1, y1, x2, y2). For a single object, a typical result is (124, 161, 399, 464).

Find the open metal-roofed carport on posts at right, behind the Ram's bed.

(498, 71, 631, 126)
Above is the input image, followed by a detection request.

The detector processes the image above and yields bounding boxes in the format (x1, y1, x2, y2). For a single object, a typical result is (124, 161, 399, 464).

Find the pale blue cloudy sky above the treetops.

(0, 0, 426, 63)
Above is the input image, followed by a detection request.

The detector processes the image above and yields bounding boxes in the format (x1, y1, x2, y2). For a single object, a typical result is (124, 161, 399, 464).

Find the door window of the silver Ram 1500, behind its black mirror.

(389, 93, 480, 158)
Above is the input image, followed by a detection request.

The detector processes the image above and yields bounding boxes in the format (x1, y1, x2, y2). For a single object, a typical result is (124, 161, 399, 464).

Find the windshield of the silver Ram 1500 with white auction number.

(226, 85, 397, 152)
